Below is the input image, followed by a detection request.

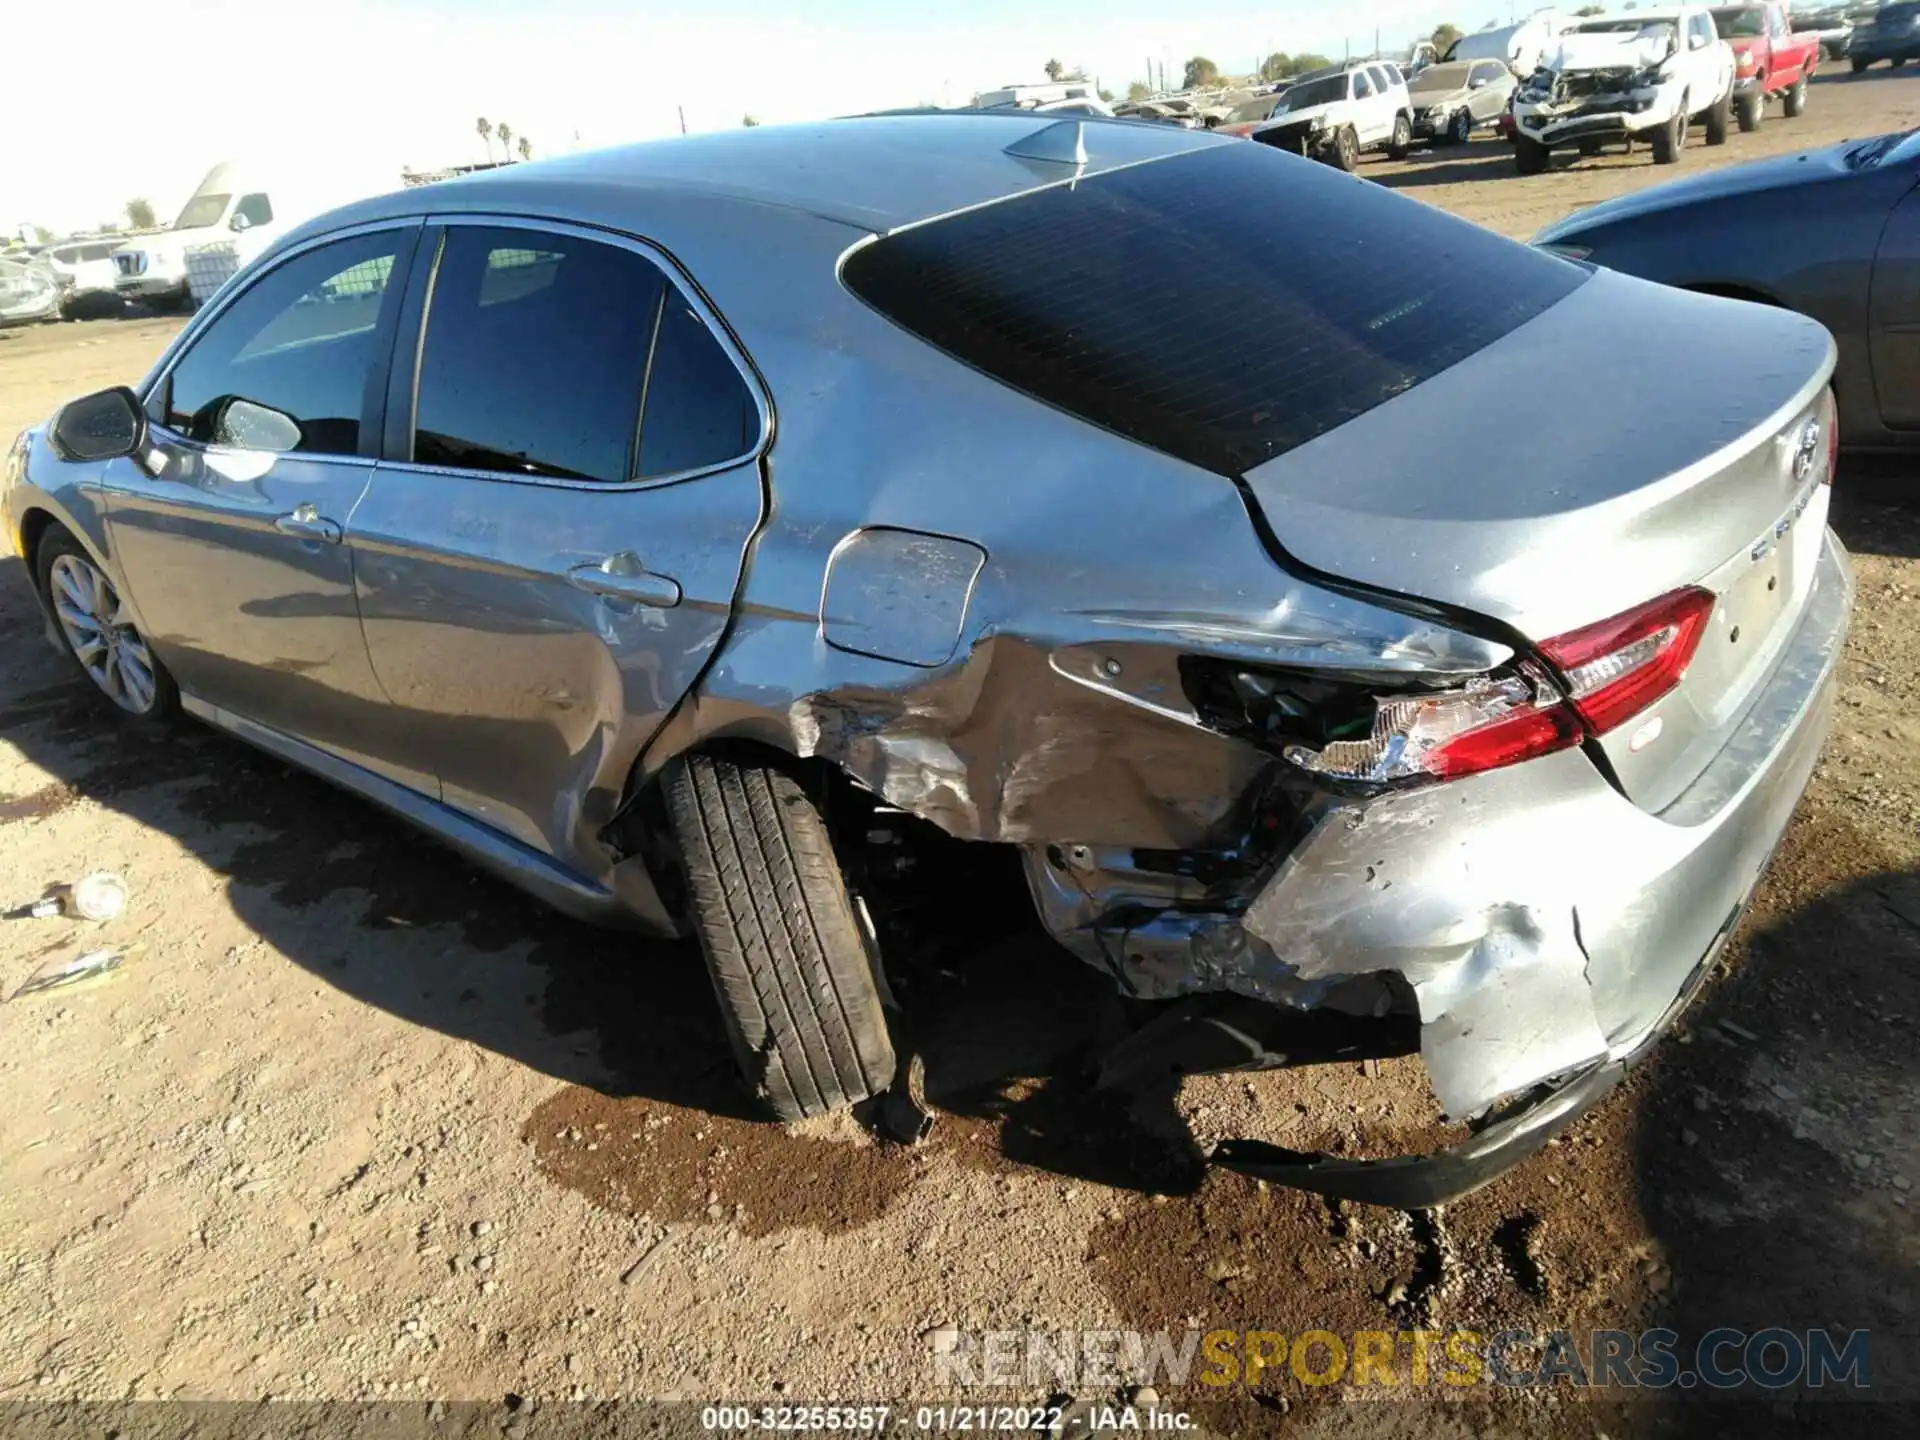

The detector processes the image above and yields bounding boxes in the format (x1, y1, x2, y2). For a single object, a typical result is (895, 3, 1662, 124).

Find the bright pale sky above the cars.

(0, 0, 1497, 230)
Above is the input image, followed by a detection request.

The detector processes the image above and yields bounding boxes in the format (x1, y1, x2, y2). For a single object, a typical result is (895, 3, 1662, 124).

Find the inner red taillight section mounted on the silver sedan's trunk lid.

(1540, 586, 1713, 735)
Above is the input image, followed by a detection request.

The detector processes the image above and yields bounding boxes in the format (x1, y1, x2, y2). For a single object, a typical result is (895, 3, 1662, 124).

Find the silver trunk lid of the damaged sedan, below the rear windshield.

(1246, 271, 1834, 810)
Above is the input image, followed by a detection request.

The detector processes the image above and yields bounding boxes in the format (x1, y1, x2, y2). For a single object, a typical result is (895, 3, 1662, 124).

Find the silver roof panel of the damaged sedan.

(305, 109, 1233, 232)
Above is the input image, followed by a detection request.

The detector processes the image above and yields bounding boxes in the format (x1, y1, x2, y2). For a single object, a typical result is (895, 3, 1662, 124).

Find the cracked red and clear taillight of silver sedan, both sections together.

(1284, 588, 1713, 783)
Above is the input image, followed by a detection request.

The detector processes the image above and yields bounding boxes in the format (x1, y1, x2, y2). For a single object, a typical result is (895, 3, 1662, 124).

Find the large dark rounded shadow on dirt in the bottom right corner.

(1634, 810, 1920, 1434)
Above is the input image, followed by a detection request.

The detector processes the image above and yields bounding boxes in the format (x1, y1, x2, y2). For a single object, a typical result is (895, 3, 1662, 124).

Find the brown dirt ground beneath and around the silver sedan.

(0, 71, 1920, 1436)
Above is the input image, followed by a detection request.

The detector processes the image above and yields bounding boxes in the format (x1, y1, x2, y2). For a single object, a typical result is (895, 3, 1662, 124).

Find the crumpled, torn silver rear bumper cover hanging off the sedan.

(1029, 534, 1853, 1208)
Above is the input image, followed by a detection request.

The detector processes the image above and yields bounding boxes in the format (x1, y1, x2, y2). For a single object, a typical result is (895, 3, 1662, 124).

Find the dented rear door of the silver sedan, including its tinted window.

(353, 219, 770, 872)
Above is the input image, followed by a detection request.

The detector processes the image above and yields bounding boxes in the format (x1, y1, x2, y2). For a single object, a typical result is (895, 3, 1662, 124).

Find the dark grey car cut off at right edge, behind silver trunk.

(1534, 131, 1920, 449)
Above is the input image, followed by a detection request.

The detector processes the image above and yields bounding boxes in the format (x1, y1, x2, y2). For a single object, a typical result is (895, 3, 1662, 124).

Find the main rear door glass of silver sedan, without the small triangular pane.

(413, 227, 666, 482)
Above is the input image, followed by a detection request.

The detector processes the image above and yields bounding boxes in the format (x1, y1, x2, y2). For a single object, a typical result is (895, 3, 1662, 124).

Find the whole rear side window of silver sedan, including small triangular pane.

(413, 227, 758, 484)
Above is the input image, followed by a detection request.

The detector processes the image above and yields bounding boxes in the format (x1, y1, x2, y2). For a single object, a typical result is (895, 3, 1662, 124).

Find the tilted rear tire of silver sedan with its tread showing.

(666, 755, 895, 1119)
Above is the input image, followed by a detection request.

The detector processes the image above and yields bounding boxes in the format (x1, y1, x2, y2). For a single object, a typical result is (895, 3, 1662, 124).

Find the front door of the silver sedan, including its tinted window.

(104, 223, 419, 779)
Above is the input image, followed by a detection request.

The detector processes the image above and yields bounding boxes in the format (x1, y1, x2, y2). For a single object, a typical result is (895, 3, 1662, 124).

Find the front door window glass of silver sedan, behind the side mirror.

(157, 230, 405, 455)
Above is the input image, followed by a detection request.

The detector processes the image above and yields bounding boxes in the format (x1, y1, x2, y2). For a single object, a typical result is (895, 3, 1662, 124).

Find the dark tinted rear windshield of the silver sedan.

(845, 140, 1588, 476)
